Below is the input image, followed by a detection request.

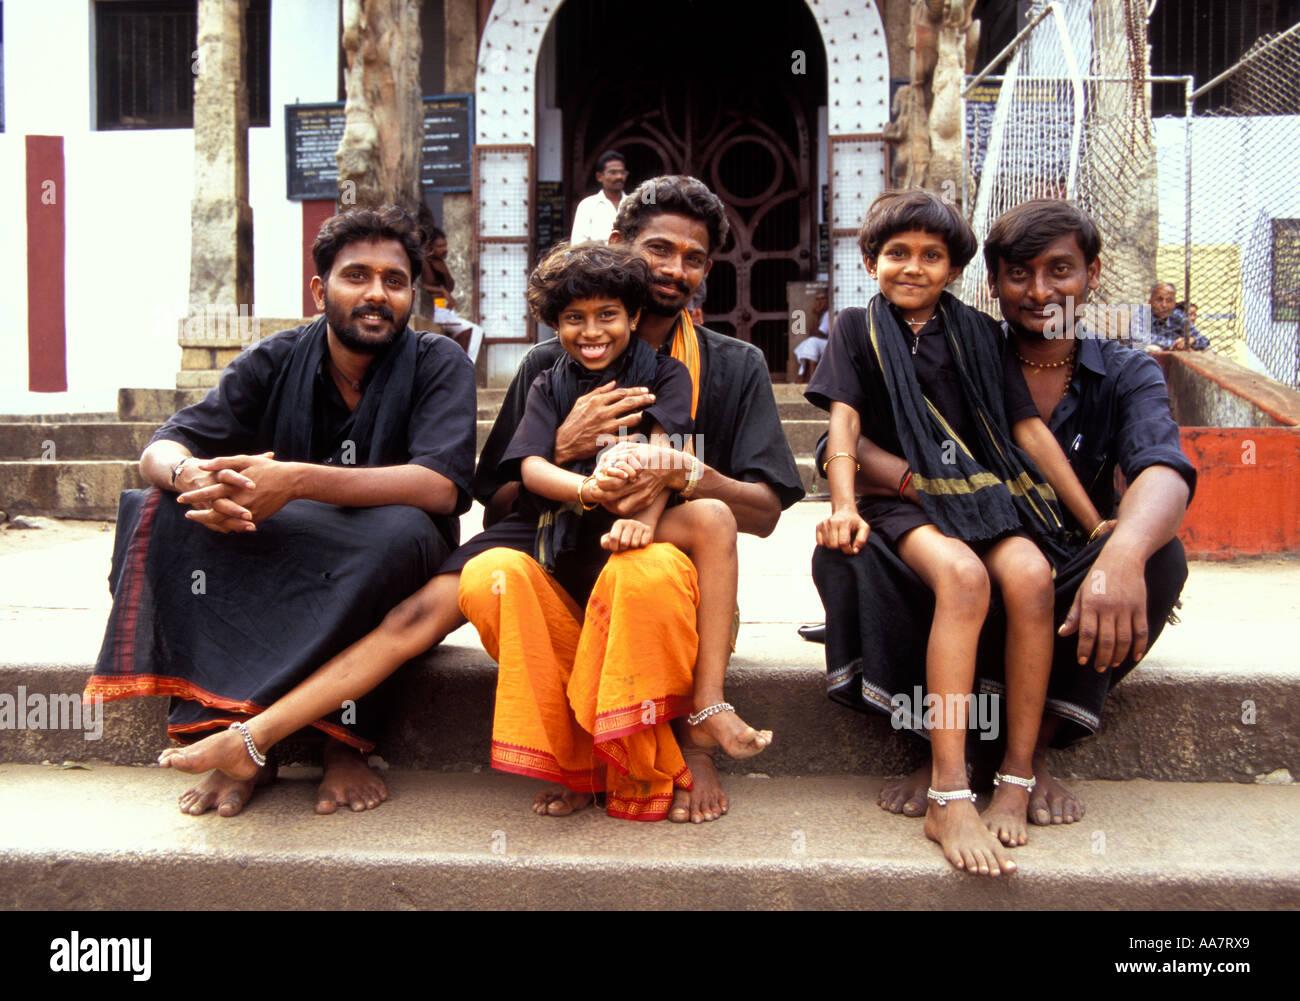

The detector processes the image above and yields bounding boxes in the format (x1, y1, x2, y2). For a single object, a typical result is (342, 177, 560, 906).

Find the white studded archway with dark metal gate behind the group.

(475, 0, 889, 369)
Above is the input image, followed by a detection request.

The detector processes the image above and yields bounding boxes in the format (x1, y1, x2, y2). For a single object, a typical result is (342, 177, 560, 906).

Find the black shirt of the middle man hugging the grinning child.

(475, 326, 803, 508)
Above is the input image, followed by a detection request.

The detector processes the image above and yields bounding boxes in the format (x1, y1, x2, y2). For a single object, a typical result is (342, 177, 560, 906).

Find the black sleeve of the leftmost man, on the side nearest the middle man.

(407, 335, 478, 515)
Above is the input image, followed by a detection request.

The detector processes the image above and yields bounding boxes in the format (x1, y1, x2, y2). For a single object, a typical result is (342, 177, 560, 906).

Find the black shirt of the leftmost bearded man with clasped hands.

(151, 325, 476, 515)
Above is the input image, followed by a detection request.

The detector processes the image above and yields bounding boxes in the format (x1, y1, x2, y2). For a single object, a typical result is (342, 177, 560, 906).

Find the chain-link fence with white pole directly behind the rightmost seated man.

(962, 0, 1157, 337)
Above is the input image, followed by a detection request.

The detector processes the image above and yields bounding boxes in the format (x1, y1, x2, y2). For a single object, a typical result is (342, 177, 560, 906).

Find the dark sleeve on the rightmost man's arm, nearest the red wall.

(1115, 351, 1196, 503)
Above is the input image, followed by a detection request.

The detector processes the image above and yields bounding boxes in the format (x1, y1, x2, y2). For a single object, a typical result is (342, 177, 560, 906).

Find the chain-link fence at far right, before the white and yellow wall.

(1154, 23, 1300, 386)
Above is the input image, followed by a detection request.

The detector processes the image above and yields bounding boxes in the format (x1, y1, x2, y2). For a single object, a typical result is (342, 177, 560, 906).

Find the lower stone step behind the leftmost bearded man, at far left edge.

(0, 459, 144, 520)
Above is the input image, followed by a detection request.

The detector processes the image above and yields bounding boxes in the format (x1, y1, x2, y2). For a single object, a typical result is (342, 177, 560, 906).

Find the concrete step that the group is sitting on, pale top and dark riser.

(0, 503, 1300, 783)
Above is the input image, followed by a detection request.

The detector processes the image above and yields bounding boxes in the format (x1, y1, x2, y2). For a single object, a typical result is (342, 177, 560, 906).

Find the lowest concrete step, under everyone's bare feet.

(0, 766, 1300, 910)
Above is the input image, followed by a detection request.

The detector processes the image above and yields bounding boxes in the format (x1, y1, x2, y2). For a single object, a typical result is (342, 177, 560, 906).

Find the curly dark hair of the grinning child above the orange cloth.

(528, 243, 650, 326)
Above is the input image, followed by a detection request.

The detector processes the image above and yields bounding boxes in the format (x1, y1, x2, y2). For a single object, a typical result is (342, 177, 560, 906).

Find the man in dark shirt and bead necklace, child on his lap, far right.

(813, 199, 1196, 824)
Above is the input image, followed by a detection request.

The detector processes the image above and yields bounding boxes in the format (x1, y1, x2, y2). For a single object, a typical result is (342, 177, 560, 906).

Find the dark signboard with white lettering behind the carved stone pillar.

(285, 94, 473, 202)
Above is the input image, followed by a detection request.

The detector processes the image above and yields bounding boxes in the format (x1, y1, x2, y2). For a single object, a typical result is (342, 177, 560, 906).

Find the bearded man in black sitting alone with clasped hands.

(86, 207, 476, 816)
